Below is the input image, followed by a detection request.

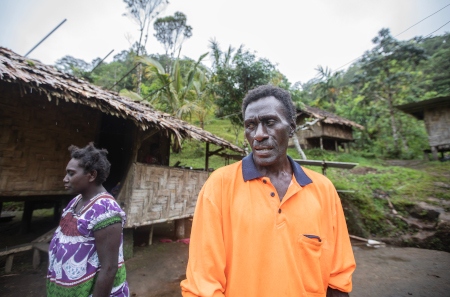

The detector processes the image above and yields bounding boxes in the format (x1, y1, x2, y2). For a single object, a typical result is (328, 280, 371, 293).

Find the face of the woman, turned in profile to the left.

(63, 159, 95, 194)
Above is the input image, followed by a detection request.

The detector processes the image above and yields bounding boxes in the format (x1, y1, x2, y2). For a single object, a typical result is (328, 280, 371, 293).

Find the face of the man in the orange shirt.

(244, 96, 295, 166)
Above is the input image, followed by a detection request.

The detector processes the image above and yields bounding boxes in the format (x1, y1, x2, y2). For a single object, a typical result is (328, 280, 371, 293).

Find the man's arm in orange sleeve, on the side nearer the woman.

(180, 182, 226, 297)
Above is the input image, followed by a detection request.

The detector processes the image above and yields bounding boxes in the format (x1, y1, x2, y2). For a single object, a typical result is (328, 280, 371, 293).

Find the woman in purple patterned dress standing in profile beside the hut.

(47, 143, 129, 297)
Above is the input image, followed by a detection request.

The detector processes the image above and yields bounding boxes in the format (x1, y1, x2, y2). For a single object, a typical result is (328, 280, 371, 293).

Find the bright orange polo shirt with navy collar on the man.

(181, 154, 355, 297)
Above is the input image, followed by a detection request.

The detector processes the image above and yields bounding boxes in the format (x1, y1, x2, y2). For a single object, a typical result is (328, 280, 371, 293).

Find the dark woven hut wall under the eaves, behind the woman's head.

(0, 83, 100, 196)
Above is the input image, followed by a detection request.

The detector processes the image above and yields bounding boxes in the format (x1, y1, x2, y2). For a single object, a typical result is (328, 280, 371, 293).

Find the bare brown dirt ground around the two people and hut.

(0, 214, 450, 297)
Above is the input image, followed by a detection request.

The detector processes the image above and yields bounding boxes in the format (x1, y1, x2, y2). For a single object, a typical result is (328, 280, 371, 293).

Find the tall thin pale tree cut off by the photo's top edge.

(123, 0, 169, 94)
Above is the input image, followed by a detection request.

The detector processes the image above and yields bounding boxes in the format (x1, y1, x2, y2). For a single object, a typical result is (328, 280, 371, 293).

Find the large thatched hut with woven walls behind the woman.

(0, 47, 244, 250)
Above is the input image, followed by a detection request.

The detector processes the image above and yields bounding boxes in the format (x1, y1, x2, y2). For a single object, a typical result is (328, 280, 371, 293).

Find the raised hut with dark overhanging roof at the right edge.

(396, 96, 450, 160)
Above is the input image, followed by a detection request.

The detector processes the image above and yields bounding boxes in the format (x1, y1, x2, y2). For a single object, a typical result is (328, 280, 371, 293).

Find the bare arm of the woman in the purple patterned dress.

(93, 223, 122, 297)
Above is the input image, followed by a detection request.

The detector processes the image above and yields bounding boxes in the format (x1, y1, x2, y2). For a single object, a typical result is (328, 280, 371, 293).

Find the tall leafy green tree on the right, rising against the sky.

(355, 29, 426, 156)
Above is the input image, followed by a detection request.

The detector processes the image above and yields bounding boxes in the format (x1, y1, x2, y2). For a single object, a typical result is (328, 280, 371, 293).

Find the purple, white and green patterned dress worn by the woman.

(47, 192, 129, 297)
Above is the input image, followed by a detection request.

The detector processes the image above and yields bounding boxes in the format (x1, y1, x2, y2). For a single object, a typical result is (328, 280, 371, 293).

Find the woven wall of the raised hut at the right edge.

(424, 107, 450, 147)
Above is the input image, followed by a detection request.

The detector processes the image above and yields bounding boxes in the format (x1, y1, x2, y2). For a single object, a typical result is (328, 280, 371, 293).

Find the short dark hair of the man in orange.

(242, 85, 297, 123)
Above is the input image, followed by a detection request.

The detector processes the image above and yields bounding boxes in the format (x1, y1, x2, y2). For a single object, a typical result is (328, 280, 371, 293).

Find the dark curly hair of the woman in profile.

(69, 142, 111, 185)
